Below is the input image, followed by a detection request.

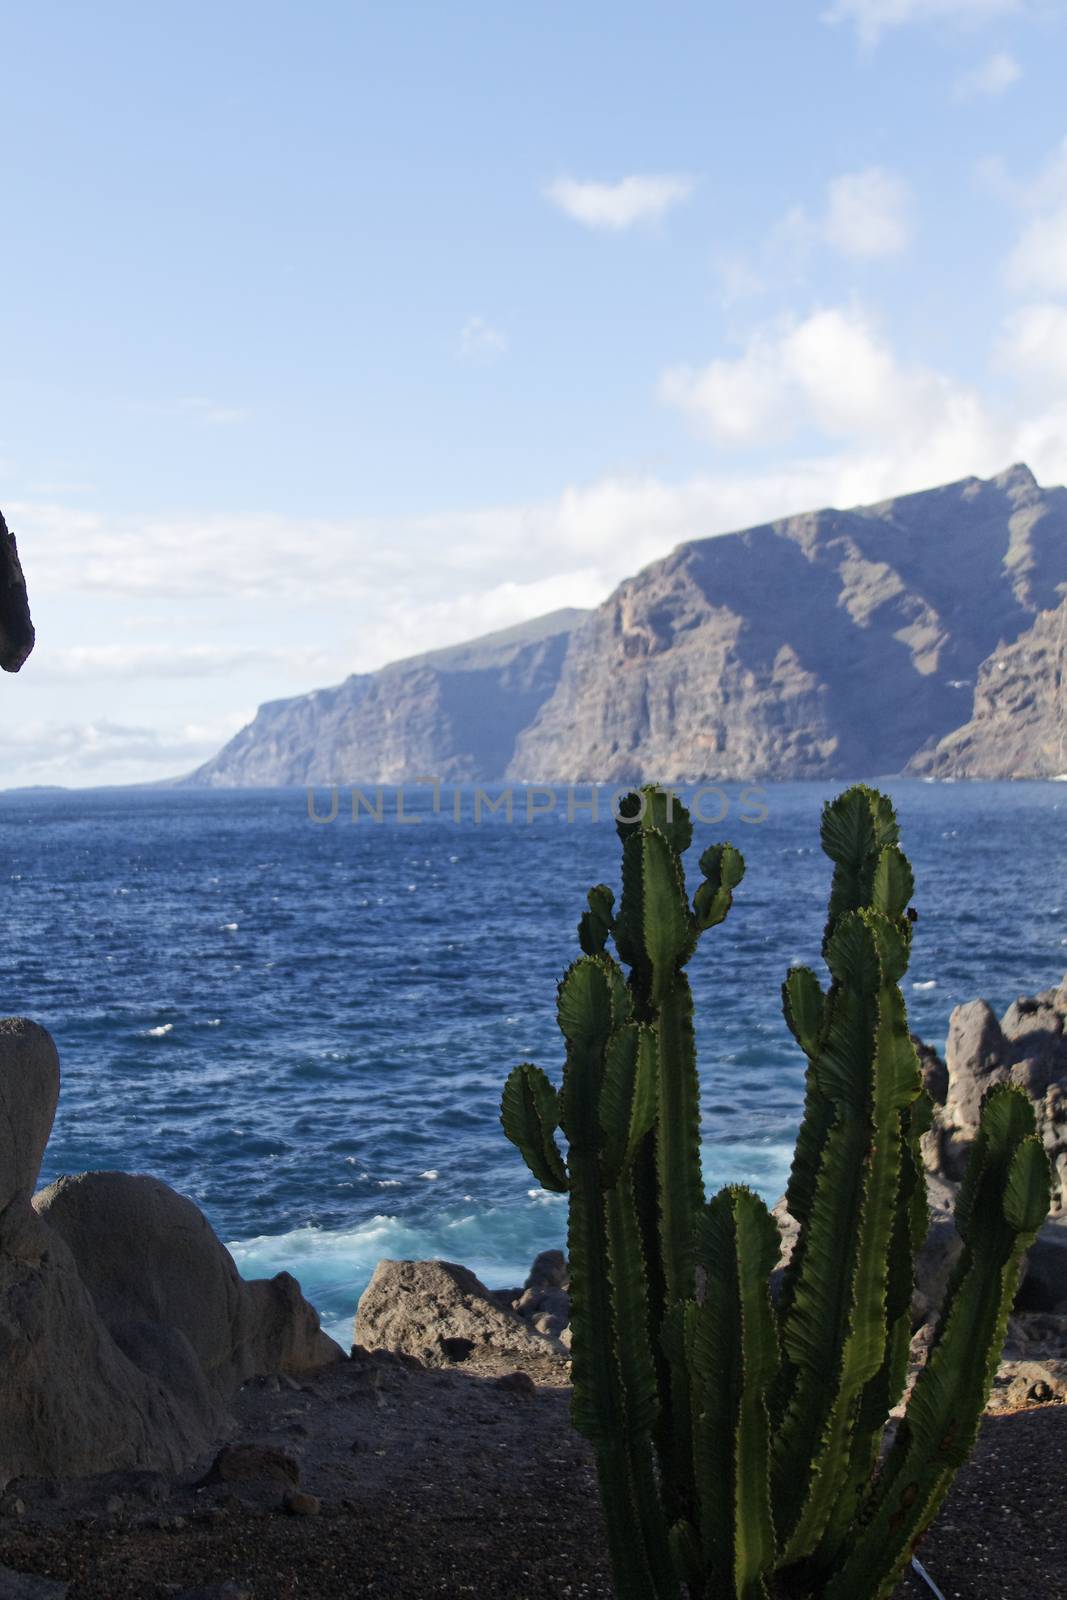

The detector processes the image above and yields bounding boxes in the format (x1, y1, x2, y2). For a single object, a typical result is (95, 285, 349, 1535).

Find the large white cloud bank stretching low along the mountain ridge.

(16, 283, 1067, 782)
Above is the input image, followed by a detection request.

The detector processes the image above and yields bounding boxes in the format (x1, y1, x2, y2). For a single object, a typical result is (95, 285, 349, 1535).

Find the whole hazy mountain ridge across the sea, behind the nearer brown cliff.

(187, 466, 1067, 786)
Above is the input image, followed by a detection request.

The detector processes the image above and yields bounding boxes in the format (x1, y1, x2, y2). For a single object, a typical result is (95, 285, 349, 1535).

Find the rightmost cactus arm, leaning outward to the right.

(824, 1085, 1049, 1600)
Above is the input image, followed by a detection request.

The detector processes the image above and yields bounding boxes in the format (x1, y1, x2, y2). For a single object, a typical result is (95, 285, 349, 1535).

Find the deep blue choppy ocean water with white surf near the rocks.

(0, 781, 1067, 1342)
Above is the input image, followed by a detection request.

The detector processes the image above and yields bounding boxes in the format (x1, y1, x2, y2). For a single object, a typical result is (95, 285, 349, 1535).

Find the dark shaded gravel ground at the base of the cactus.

(0, 1357, 1067, 1600)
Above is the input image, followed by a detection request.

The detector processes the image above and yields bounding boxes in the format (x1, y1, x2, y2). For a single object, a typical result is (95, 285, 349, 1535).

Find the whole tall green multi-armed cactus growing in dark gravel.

(501, 786, 1049, 1600)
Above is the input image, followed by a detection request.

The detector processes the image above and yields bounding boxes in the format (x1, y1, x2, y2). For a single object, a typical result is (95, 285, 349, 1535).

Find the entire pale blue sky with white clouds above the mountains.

(0, 0, 1067, 787)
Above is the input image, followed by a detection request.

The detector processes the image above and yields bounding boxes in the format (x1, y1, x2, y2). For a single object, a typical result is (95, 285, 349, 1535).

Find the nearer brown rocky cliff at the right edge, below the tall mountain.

(910, 600, 1067, 778)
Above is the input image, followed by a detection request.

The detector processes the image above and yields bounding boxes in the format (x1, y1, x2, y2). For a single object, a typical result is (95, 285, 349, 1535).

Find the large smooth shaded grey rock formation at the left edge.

(0, 1018, 342, 1483)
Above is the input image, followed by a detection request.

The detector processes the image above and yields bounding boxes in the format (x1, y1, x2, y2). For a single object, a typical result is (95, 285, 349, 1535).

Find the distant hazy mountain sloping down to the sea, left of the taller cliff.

(184, 611, 585, 789)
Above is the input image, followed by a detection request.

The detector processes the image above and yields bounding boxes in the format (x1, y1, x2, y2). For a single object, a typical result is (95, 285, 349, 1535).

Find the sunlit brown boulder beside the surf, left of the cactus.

(354, 1261, 560, 1366)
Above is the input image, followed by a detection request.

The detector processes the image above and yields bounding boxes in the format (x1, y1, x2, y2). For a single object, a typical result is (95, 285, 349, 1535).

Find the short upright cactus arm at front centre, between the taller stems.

(691, 1186, 779, 1600)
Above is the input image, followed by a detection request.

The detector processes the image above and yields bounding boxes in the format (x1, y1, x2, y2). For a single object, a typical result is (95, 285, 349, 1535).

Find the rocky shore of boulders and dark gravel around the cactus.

(0, 978, 1067, 1600)
